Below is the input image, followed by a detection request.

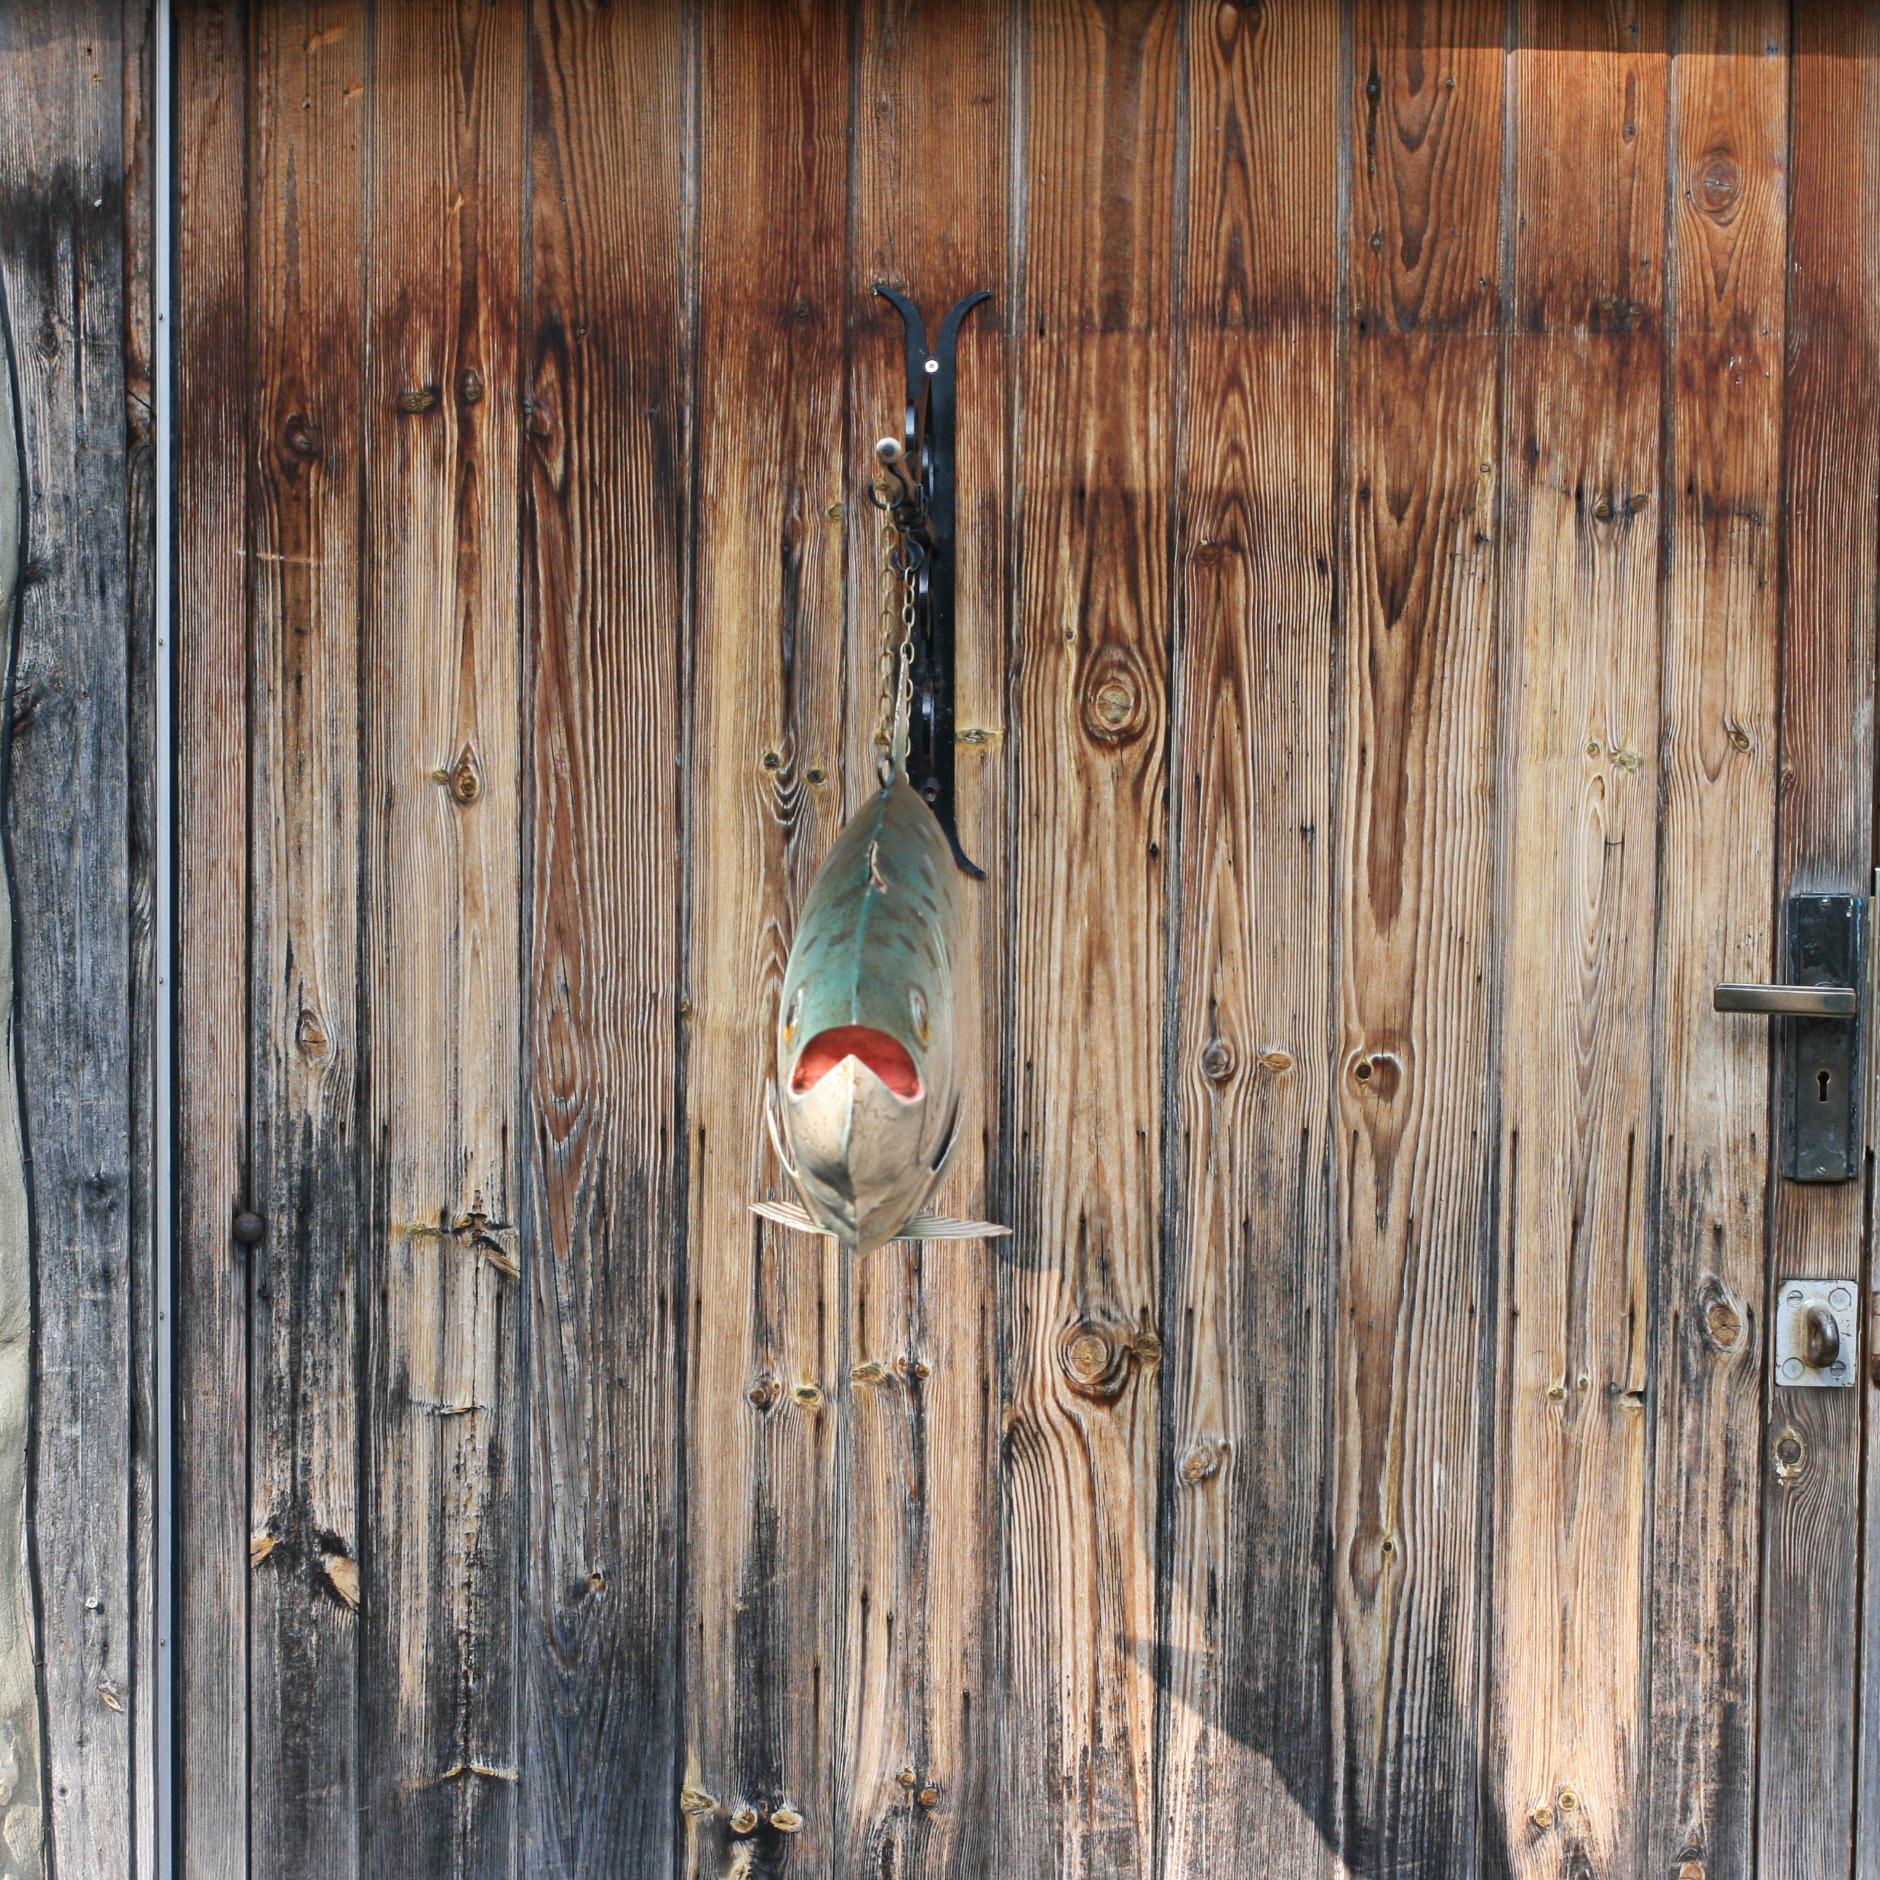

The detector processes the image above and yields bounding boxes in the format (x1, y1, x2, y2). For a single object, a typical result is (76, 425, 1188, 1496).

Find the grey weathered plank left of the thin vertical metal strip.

(0, 0, 135, 1876)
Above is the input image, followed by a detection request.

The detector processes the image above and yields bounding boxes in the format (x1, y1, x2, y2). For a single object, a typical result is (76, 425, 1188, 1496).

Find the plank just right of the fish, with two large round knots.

(1000, 0, 1181, 1880)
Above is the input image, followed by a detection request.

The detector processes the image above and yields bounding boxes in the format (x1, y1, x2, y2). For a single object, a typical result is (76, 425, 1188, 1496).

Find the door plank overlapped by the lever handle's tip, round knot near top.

(1645, 0, 1788, 1880)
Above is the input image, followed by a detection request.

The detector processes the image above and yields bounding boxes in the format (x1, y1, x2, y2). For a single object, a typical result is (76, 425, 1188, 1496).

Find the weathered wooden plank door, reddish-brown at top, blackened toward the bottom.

(157, 0, 1880, 1880)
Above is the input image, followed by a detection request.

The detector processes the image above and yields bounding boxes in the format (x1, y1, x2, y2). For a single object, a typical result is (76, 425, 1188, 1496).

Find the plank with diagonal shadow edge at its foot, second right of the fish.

(1158, 0, 1346, 1876)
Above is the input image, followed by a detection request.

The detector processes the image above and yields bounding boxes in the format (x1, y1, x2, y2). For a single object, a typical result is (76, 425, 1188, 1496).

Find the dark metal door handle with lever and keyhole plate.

(1716, 895, 1867, 1181)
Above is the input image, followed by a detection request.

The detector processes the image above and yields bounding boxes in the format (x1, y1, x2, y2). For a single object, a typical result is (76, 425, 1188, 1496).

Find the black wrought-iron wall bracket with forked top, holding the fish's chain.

(874, 286, 993, 880)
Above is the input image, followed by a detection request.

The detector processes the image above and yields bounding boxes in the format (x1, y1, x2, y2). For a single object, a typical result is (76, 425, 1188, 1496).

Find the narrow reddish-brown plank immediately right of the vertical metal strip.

(171, 4, 248, 1880)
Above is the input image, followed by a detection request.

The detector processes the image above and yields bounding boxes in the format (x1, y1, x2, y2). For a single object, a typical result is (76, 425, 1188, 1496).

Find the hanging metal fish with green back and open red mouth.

(754, 767, 1008, 1252)
